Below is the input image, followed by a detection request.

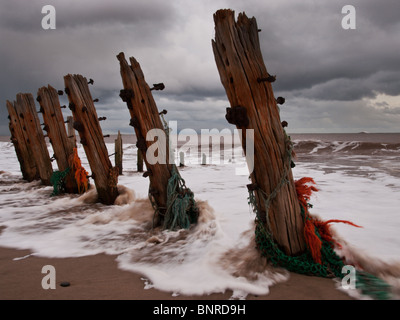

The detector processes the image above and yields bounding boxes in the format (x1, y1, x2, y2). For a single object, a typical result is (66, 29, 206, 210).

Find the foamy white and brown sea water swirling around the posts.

(0, 134, 400, 299)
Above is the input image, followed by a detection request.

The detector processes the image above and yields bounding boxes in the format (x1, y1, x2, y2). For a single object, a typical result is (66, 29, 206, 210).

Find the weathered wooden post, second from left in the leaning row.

(15, 93, 53, 185)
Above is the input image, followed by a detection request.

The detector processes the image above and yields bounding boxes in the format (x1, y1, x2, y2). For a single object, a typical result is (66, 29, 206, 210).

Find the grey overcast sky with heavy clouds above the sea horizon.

(0, 0, 400, 135)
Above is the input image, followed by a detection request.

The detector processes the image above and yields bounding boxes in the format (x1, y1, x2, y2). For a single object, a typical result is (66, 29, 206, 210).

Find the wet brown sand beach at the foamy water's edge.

(0, 248, 351, 300)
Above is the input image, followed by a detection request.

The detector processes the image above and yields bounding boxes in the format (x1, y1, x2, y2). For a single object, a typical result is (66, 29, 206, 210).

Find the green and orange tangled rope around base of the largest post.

(248, 131, 391, 300)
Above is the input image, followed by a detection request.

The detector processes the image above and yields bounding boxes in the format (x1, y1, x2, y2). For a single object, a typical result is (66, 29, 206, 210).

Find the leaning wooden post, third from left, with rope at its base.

(37, 85, 78, 193)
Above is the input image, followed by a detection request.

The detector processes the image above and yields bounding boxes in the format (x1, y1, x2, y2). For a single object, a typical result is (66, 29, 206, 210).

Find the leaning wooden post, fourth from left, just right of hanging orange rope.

(64, 74, 118, 204)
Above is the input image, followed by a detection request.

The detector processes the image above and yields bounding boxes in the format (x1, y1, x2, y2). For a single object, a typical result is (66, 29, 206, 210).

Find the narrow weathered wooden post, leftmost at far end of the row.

(6, 100, 39, 182)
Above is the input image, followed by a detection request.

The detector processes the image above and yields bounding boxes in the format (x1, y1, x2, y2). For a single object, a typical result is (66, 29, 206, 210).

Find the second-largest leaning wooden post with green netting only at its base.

(117, 52, 198, 229)
